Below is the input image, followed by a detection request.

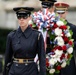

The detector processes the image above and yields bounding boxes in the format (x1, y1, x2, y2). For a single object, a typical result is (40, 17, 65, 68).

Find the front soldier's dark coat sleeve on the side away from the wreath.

(3, 35, 13, 75)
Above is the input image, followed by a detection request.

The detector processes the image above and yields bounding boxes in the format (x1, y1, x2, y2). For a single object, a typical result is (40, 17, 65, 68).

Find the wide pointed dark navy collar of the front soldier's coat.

(17, 26, 32, 38)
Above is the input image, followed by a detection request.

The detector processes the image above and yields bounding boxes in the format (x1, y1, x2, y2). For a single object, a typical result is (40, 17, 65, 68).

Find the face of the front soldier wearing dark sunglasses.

(17, 16, 30, 27)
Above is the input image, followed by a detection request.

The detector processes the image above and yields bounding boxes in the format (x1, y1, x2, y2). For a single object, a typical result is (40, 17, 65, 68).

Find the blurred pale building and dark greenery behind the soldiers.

(0, 0, 76, 73)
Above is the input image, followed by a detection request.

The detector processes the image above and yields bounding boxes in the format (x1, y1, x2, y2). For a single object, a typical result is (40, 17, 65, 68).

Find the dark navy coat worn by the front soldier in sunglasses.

(3, 26, 46, 75)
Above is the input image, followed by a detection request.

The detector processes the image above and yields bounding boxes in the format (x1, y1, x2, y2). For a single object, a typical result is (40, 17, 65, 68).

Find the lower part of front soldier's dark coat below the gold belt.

(8, 62, 38, 75)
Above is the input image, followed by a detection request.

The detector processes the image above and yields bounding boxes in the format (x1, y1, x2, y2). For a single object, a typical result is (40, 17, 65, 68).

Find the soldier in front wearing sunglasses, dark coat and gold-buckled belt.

(3, 7, 46, 75)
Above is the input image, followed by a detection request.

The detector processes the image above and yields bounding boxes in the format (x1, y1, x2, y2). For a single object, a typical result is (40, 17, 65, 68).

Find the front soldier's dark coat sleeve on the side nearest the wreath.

(38, 33, 46, 75)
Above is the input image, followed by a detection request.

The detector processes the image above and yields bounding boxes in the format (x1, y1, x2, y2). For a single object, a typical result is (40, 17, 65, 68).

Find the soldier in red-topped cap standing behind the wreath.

(55, 3, 76, 75)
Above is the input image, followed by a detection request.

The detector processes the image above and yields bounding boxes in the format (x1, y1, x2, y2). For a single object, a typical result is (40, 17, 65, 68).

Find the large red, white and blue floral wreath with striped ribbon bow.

(30, 9, 74, 75)
